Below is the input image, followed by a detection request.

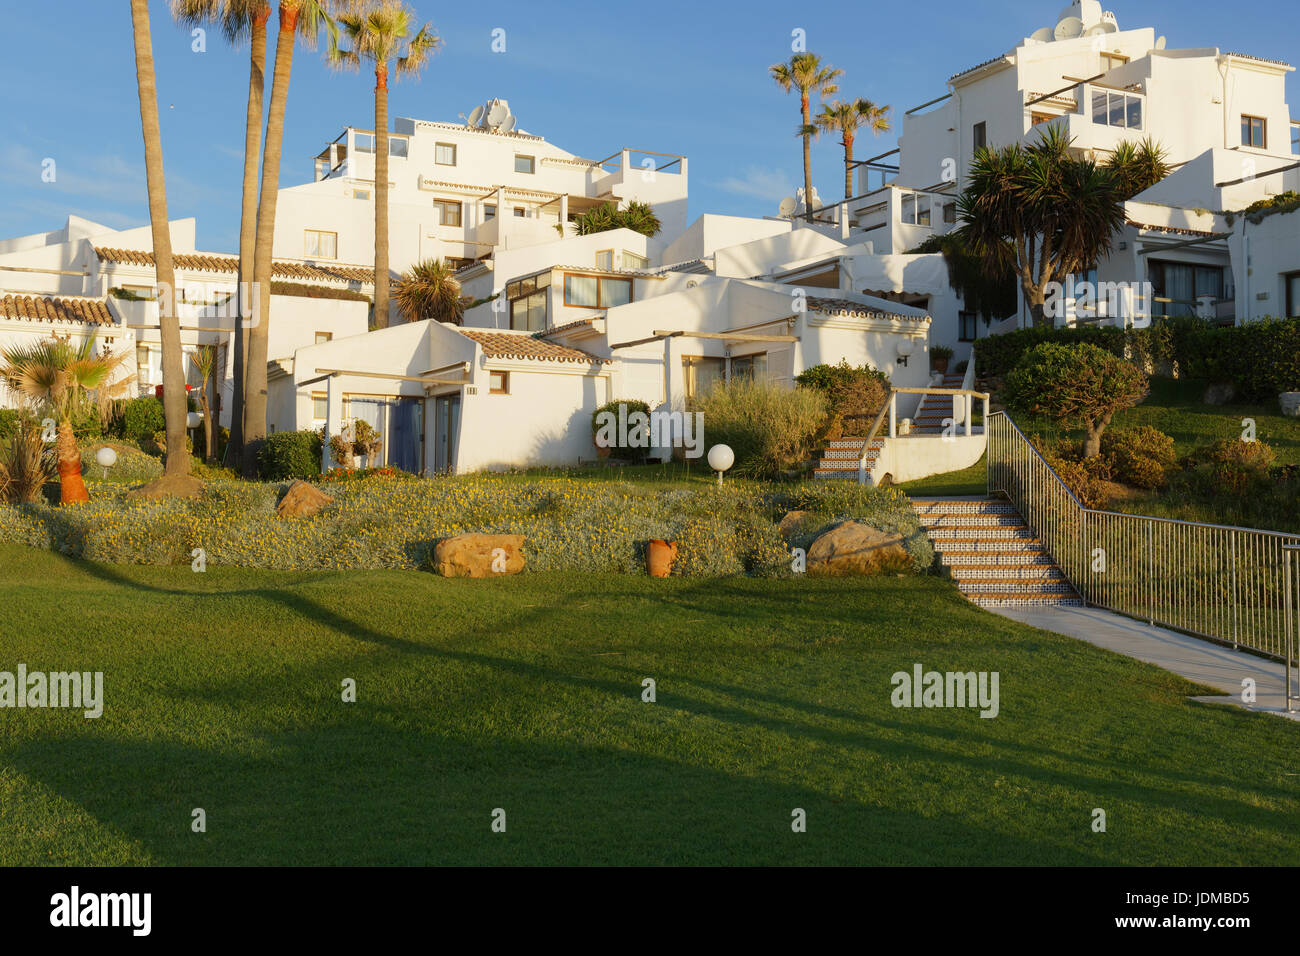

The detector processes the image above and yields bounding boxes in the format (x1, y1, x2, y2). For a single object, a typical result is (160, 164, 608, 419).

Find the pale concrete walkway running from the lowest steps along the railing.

(988, 607, 1300, 721)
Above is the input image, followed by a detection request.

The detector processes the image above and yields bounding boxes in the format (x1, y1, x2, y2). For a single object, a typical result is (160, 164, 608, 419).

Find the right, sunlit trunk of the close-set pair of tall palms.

(241, 0, 298, 477)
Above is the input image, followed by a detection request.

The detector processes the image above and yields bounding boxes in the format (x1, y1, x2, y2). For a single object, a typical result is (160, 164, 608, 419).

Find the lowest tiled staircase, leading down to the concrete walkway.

(911, 498, 1083, 607)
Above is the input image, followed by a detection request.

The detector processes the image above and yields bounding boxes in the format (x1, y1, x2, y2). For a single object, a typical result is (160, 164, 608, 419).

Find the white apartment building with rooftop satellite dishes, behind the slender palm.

(274, 100, 688, 300)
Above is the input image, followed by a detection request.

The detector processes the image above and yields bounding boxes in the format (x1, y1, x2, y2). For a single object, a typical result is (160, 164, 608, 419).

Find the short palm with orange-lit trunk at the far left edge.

(0, 335, 131, 505)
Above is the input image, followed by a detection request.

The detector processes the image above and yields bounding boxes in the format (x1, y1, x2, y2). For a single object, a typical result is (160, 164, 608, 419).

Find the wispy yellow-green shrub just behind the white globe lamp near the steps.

(692, 381, 827, 479)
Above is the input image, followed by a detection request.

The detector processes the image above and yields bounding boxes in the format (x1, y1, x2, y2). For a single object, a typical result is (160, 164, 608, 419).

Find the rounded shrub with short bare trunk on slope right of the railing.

(1002, 342, 1148, 458)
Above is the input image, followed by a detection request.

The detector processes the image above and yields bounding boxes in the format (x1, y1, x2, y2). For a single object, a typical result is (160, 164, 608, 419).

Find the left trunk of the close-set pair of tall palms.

(230, 4, 270, 467)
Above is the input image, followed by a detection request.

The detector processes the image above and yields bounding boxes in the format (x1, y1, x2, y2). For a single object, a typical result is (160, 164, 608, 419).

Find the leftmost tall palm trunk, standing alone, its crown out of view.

(130, 0, 190, 476)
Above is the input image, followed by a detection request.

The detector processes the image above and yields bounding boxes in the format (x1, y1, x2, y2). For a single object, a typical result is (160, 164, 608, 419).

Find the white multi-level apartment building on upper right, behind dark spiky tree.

(801, 0, 1300, 351)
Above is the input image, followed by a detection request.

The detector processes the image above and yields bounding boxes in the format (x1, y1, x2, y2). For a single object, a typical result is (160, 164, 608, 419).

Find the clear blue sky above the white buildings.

(0, 0, 1300, 252)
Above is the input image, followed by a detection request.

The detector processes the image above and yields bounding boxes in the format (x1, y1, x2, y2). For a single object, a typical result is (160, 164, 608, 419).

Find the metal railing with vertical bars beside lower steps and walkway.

(984, 412, 1300, 691)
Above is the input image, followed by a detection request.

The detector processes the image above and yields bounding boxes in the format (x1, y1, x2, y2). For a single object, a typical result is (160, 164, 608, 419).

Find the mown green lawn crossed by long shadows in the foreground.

(0, 545, 1300, 865)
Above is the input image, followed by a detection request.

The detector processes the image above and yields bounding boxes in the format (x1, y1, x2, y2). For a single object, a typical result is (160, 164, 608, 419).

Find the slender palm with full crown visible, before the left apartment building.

(329, 0, 442, 329)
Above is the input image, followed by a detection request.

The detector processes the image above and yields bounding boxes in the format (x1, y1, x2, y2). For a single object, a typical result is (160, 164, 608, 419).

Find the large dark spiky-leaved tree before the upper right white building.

(957, 125, 1125, 325)
